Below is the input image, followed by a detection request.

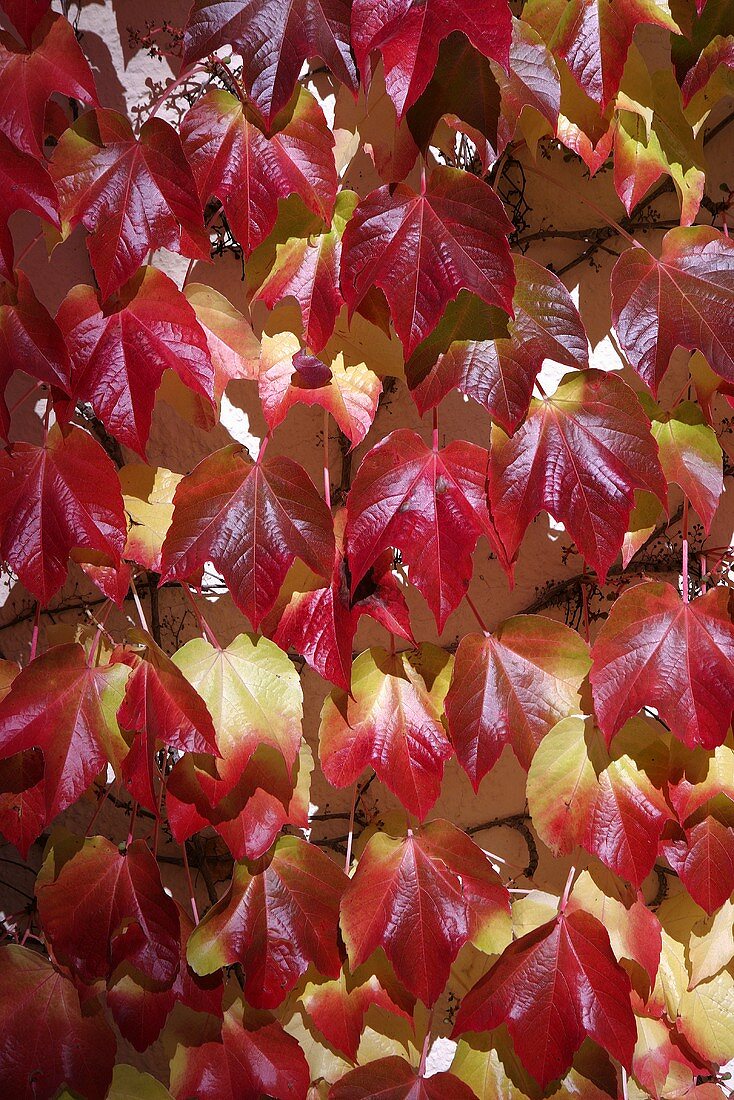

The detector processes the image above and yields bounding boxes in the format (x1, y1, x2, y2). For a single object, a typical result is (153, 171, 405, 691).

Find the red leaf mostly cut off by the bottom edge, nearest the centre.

(329, 1056, 474, 1100)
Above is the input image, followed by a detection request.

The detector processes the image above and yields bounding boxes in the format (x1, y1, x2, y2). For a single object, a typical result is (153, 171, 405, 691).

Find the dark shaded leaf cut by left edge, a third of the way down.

(0, 269, 70, 439)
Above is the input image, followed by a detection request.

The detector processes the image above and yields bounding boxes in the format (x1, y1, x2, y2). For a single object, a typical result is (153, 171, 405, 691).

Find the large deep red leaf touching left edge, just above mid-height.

(0, 427, 128, 604)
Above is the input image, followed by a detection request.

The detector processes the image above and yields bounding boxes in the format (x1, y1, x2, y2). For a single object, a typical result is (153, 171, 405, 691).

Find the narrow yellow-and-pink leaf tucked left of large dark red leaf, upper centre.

(255, 190, 358, 352)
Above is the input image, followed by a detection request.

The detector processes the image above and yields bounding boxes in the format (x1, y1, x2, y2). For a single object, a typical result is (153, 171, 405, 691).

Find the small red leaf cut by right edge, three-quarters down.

(662, 817, 734, 914)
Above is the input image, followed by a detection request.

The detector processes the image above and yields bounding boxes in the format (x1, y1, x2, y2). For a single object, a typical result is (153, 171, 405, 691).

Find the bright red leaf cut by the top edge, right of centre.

(352, 0, 512, 122)
